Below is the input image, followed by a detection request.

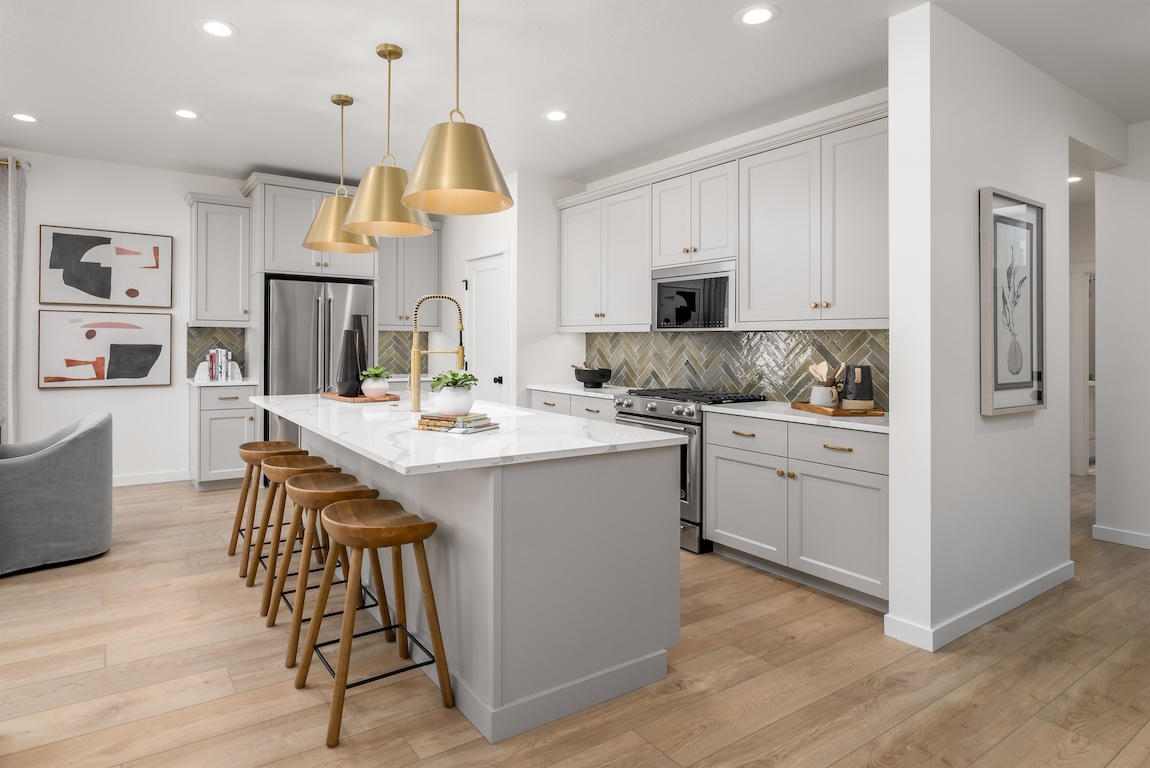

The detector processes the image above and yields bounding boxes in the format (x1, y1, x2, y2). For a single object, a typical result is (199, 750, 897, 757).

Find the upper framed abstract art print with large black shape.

(40, 224, 173, 309)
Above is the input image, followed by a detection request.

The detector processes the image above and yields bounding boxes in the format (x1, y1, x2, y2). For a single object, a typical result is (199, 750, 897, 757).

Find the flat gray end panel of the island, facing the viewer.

(497, 446, 680, 724)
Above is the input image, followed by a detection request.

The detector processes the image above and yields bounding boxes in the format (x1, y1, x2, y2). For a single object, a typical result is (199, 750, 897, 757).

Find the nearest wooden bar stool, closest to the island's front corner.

(296, 499, 455, 746)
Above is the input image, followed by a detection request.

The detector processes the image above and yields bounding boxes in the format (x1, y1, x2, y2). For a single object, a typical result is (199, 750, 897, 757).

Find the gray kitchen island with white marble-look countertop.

(251, 394, 684, 742)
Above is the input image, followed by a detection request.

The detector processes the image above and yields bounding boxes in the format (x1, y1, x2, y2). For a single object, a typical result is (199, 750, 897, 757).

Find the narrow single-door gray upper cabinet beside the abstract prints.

(186, 192, 252, 328)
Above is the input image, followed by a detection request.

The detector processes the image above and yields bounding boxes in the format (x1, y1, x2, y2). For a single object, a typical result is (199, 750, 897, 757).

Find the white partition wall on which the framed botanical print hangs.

(887, 5, 1126, 650)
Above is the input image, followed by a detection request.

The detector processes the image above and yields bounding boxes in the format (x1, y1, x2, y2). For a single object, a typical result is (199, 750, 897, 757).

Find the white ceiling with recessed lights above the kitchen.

(0, 0, 1150, 182)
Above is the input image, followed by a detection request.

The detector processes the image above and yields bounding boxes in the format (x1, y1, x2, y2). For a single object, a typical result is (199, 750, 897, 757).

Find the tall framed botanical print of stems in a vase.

(979, 186, 1047, 416)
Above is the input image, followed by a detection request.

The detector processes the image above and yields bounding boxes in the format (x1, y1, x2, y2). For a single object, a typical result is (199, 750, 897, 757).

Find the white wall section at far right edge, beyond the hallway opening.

(1094, 122, 1150, 550)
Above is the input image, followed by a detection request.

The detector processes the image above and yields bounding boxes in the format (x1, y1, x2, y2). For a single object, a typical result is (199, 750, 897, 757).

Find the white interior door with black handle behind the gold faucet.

(465, 254, 512, 405)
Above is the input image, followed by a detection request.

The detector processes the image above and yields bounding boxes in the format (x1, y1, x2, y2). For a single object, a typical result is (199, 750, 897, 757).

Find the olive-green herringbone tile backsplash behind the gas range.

(587, 330, 890, 410)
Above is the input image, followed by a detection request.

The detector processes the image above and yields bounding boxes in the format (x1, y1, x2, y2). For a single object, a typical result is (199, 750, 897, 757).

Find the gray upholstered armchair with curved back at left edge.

(0, 410, 112, 575)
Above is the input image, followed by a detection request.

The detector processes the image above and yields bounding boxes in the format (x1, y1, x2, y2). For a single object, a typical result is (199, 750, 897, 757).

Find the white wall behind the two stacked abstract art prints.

(0, 149, 240, 485)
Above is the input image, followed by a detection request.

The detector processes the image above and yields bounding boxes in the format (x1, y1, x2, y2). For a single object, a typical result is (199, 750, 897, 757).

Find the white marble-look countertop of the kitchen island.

(251, 394, 685, 475)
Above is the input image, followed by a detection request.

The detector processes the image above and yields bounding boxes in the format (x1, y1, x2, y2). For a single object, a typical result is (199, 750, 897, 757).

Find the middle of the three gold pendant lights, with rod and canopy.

(344, 43, 431, 237)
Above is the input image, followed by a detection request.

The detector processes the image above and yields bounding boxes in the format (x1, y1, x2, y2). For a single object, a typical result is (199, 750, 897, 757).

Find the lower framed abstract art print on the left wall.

(37, 309, 171, 390)
